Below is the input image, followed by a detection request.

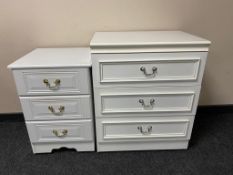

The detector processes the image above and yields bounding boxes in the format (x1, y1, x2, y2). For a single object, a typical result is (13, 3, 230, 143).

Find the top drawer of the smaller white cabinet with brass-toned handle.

(13, 68, 91, 95)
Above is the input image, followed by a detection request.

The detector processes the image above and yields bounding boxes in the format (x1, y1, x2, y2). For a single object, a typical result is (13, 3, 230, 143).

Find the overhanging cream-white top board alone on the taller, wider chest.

(90, 31, 210, 47)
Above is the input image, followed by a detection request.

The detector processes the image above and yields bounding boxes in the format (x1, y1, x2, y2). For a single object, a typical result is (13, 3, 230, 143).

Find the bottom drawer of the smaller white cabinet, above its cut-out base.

(26, 120, 93, 143)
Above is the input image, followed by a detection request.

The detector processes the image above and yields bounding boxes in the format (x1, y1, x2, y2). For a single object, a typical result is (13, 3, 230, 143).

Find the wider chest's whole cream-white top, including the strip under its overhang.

(90, 31, 210, 53)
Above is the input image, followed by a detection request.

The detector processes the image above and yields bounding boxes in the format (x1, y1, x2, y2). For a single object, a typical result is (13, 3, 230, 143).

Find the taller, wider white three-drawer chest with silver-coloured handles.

(91, 31, 210, 151)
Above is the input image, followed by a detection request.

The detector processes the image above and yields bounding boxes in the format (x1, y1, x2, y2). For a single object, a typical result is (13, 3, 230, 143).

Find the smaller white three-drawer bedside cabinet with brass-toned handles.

(8, 48, 94, 153)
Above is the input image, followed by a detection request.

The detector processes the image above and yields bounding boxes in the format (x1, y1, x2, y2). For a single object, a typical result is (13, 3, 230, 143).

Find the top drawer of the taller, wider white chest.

(92, 52, 207, 86)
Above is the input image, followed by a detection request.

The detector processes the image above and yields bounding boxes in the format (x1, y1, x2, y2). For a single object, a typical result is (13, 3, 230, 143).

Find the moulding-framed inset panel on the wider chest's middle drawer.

(101, 92, 194, 114)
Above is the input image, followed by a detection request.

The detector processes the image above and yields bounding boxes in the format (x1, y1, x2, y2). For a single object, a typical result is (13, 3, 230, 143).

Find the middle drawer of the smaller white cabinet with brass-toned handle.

(20, 95, 92, 120)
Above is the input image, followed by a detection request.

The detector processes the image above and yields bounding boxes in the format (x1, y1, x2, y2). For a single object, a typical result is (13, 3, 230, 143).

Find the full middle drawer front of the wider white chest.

(95, 87, 200, 117)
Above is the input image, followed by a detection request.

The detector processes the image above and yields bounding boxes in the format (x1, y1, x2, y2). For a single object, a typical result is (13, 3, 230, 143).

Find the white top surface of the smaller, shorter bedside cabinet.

(8, 47, 91, 69)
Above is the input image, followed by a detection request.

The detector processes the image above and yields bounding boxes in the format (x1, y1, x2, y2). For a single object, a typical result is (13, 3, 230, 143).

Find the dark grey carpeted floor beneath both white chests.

(0, 109, 233, 175)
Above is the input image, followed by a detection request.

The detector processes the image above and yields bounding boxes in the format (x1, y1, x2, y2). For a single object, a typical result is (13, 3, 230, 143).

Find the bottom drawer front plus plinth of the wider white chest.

(96, 116, 194, 152)
